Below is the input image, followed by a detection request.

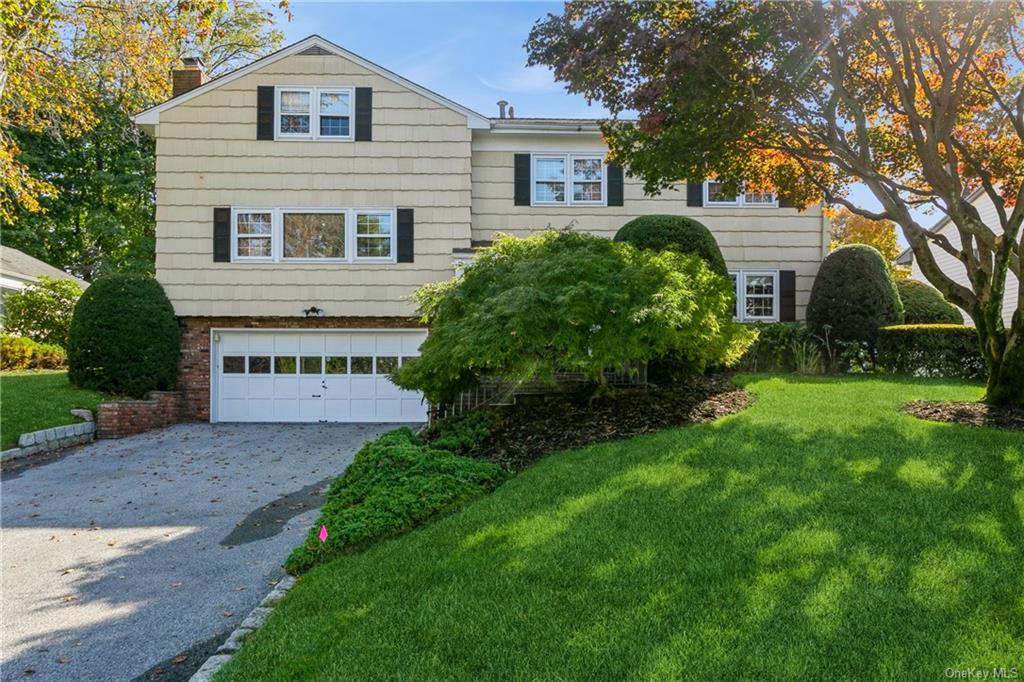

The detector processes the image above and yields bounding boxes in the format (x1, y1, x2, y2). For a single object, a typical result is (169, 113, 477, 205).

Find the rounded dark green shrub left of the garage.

(68, 274, 179, 397)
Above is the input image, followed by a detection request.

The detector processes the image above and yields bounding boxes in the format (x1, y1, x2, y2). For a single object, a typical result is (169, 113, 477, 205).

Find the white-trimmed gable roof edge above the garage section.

(132, 35, 490, 129)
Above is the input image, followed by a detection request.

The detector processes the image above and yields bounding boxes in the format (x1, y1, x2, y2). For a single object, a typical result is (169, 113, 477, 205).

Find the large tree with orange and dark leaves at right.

(526, 0, 1024, 406)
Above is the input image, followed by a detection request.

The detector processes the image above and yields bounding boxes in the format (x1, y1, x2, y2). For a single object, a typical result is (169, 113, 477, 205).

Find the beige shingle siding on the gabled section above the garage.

(157, 55, 471, 315)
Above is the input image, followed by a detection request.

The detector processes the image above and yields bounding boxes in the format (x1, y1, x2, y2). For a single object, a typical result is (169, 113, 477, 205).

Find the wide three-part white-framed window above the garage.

(231, 208, 397, 263)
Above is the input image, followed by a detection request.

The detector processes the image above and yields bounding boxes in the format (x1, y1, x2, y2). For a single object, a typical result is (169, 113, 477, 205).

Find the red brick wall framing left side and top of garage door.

(178, 317, 423, 422)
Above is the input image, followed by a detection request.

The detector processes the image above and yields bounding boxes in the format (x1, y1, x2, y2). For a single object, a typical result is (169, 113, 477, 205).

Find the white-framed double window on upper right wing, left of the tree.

(530, 154, 607, 206)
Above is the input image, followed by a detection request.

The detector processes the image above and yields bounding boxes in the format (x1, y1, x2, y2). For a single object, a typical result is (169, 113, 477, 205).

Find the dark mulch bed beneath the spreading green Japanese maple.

(476, 375, 753, 469)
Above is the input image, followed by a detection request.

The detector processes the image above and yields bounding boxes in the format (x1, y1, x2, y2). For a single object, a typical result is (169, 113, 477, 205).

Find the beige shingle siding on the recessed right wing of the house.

(472, 140, 828, 319)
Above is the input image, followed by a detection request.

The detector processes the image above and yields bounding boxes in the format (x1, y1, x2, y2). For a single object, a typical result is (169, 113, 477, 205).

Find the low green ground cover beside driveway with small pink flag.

(285, 427, 506, 574)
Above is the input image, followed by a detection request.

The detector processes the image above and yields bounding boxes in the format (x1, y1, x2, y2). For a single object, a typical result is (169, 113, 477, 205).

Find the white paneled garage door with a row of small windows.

(211, 330, 427, 422)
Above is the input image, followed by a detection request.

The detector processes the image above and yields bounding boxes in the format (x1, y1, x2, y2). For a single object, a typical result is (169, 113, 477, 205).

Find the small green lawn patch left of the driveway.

(0, 372, 104, 450)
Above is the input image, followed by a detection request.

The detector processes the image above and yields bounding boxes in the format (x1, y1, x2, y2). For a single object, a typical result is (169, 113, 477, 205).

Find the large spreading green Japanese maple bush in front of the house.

(394, 230, 754, 402)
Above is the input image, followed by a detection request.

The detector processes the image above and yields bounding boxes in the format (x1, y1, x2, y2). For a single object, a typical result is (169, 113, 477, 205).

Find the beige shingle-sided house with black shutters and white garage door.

(135, 36, 828, 421)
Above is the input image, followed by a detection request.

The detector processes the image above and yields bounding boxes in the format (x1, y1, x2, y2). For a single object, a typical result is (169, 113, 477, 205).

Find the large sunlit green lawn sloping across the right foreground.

(217, 377, 1024, 681)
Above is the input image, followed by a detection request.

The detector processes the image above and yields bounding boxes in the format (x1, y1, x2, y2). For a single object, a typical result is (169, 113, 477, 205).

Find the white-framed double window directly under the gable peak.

(274, 85, 355, 140)
